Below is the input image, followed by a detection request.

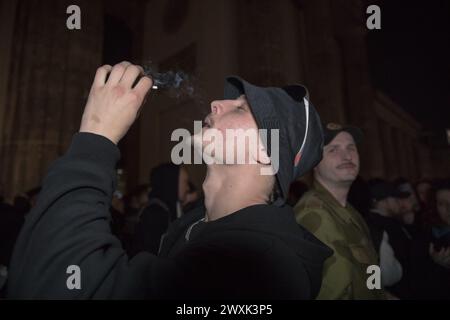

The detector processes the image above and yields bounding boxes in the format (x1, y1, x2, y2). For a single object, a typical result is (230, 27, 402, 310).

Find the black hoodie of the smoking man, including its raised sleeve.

(7, 133, 331, 299)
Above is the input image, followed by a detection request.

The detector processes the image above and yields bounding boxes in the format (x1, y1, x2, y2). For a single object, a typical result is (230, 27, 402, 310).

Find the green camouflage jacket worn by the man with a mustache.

(294, 181, 385, 299)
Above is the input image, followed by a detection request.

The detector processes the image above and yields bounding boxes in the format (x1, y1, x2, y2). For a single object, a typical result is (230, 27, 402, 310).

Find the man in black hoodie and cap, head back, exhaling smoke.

(8, 62, 330, 299)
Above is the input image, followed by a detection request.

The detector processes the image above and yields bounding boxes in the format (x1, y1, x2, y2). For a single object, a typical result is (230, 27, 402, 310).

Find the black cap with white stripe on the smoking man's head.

(224, 76, 324, 205)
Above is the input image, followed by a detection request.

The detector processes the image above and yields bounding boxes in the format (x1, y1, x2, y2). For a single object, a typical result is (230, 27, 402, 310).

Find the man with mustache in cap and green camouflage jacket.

(294, 123, 384, 299)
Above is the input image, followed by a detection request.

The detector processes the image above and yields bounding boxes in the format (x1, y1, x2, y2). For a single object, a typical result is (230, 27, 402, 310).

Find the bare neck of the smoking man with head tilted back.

(203, 165, 266, 221)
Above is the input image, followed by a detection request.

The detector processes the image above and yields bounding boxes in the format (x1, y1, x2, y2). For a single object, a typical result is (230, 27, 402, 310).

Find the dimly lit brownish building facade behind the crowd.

(0, 0, 450, 200)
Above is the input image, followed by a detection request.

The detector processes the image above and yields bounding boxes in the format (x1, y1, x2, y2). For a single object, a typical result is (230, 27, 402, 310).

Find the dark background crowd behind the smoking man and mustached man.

(0, 151, 450, 299)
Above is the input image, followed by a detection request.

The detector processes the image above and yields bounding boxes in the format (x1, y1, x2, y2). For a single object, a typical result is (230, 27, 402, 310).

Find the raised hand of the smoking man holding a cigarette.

(80, 61, 152, 144)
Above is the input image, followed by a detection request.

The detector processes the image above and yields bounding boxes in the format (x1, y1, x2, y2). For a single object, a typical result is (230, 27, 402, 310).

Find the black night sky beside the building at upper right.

(368, 0, 450, 138)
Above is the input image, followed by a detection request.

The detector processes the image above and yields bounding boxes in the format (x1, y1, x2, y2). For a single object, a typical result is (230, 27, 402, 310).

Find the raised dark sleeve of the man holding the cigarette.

(8, 133, 170, 299)
